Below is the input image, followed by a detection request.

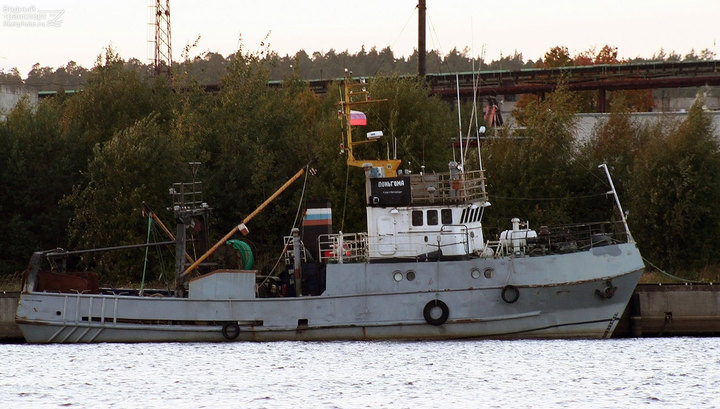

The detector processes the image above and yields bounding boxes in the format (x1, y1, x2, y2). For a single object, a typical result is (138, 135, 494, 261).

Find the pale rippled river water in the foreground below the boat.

(0, 338, 720, 409)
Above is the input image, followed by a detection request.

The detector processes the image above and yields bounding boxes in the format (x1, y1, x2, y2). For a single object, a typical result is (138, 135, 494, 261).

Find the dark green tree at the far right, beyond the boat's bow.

(629, 98, 720, 272)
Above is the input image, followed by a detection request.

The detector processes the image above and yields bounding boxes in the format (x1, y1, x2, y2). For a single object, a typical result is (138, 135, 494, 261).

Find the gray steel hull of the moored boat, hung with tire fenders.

(16, 244, 643, 343)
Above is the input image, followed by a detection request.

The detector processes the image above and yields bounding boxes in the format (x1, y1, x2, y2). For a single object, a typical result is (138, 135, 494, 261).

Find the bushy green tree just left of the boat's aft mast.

(63, 114, 185, 283)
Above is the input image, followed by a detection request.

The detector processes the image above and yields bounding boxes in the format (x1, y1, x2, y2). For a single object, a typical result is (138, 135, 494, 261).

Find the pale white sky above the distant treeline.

(0, 0, 720, 77)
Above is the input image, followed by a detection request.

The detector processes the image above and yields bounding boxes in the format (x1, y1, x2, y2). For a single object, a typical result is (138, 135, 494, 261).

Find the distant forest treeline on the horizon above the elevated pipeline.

(0, 44, 716, 91)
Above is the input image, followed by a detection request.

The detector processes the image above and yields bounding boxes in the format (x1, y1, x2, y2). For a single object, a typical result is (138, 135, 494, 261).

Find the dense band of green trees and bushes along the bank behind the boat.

(0, 46, 720, 285)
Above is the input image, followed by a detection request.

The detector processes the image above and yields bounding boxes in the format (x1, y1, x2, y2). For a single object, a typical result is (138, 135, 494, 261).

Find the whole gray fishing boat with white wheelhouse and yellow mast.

(16, 78, 643, 343)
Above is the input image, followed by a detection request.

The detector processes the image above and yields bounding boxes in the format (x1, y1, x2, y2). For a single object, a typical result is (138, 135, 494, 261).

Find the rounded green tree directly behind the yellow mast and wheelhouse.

(323, 76, 455, 231)
